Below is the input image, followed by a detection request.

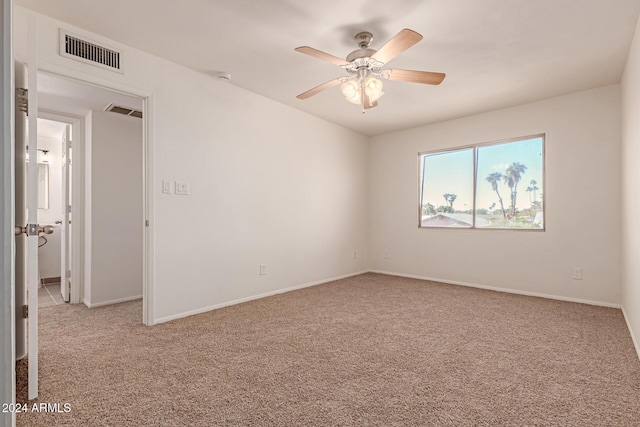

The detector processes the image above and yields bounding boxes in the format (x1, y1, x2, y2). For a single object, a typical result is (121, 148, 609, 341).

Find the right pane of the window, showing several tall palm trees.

(476, 137, 544, 229)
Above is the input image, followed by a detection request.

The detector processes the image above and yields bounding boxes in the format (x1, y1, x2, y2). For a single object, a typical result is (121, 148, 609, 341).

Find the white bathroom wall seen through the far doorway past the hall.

(36, 135, 63, 279)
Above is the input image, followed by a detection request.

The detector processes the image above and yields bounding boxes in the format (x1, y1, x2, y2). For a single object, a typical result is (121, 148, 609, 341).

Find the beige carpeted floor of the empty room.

(17, 274, 640, 426)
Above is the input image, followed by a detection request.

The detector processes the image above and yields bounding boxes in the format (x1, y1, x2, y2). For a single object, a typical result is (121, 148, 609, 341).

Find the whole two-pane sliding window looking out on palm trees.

(418, 135, 545, 230)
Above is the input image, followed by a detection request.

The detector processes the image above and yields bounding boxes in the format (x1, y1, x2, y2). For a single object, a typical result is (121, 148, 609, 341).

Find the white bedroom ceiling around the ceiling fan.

(16, 0, 640, 135)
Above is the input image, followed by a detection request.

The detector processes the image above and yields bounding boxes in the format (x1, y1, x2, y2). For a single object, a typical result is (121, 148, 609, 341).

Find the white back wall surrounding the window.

(369, 85, 621, 304)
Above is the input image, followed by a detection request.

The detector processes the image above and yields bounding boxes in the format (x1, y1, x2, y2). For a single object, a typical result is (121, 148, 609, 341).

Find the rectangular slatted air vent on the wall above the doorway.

(60, 29, 122, 73)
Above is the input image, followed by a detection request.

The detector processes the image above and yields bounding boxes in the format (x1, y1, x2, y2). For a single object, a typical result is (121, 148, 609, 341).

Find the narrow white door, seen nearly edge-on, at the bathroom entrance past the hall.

(60, 125, 71, 302)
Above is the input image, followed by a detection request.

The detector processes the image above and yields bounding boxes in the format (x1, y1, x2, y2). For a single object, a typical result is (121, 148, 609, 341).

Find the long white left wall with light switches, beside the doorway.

(16, 8, 369, 321)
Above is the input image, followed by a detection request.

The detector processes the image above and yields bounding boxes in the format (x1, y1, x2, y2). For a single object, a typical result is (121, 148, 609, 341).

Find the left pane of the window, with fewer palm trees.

(420, 148, 473, 227)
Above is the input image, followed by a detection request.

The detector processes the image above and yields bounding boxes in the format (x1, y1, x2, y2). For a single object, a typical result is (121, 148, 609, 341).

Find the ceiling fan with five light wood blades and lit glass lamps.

(295, 28, 445, 113)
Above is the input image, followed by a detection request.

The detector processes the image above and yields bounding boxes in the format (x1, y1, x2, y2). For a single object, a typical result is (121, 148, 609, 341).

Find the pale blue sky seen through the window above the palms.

(423, 137, 543, 210)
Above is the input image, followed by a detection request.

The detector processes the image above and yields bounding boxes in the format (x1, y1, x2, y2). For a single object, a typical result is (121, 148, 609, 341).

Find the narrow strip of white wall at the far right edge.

(622, 15, 640, 356)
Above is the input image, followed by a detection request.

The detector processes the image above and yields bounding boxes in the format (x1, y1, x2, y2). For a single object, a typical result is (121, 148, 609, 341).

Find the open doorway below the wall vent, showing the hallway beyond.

(38, 73, 145, 307)
